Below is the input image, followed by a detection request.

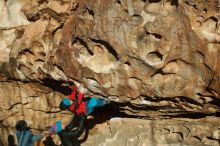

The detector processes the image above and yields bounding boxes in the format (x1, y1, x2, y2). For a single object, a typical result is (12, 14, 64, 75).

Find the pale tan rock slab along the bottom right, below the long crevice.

(82, 118, 220, 146)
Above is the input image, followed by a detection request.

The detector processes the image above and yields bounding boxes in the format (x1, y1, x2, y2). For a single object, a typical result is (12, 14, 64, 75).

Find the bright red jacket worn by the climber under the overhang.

(68, 86, 86, 115)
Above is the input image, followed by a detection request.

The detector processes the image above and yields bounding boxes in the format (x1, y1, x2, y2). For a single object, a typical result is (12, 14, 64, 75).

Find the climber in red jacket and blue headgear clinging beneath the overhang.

(59, 86, 110, 132)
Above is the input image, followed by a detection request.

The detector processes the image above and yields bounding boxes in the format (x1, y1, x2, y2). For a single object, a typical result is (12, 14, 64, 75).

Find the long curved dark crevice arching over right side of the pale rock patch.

(91, 38, 119, 61)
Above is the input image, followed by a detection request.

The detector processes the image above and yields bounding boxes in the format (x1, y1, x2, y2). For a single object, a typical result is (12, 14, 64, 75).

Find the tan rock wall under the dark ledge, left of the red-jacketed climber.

(0, 81, 72, 145)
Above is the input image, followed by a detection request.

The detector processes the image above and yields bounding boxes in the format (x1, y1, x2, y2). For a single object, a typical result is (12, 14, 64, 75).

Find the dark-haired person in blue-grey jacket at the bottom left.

(15, 120, 43, 146)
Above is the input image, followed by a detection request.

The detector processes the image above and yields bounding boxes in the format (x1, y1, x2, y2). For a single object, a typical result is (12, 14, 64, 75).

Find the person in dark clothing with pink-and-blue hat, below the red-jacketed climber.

(49, 121, 83, 146)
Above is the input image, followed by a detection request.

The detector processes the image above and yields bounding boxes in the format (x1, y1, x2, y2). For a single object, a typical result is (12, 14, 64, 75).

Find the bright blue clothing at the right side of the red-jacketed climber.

(86, 97, 106, 115)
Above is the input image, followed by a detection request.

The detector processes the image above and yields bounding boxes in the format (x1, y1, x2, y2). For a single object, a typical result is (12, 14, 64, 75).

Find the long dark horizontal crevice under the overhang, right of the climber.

(84, 99, 220, 129)
